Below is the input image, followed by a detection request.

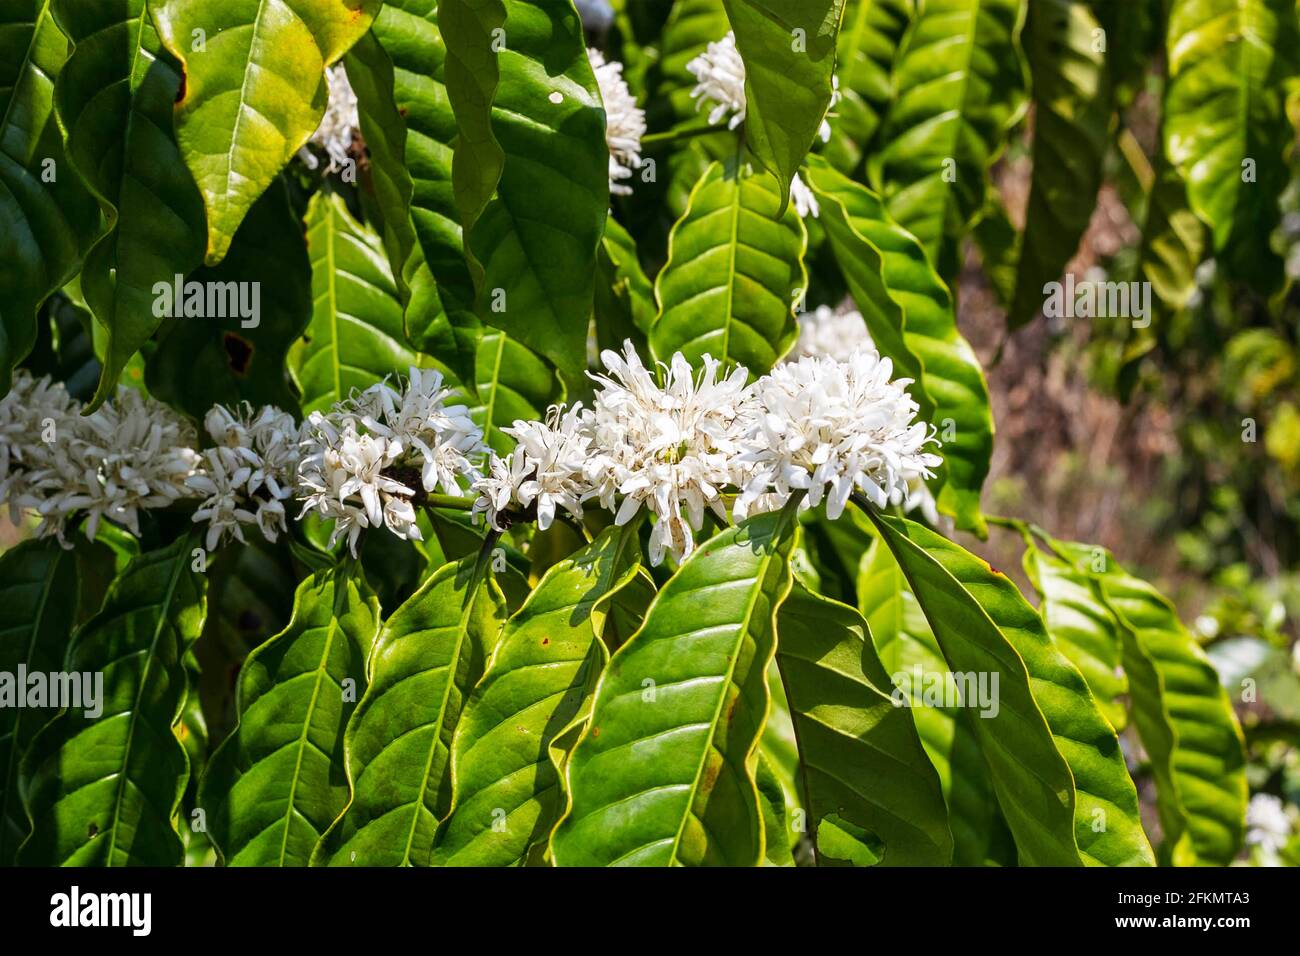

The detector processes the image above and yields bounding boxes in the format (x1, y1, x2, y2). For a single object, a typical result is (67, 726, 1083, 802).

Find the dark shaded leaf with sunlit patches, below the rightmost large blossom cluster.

(776, 581, 953, 866)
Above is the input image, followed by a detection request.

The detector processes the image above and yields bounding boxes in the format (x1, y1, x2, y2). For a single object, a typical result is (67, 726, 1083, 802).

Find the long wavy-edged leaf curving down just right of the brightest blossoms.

(809, 159, 993, 536)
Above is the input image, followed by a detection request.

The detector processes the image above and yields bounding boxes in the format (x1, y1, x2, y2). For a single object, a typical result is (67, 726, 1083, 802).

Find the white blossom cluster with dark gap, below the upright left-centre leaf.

(298, 368, 486, 554)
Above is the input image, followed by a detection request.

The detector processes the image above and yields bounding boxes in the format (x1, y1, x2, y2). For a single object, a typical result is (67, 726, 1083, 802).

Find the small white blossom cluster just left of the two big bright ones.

(473, 403, 592, 531)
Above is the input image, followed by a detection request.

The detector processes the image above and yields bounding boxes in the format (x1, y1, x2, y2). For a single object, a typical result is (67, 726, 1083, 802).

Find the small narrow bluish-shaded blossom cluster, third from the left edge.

(186, 403, 299, 551)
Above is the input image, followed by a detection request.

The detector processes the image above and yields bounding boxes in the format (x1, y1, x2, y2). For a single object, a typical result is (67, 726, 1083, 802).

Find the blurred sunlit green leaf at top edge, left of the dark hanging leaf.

(870, 0, 1024, 280)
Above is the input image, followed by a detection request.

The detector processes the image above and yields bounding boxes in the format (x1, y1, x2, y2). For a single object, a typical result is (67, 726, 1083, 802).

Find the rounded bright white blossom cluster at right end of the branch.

(733, 351, 943, 520)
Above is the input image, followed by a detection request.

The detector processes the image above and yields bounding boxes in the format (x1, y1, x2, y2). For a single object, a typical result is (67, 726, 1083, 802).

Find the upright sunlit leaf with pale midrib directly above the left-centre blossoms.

(289, 193, 432, 415)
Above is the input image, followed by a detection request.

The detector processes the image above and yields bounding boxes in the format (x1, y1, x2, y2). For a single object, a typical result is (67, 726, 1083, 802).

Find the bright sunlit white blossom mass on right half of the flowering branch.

(475, 343, 941, 564)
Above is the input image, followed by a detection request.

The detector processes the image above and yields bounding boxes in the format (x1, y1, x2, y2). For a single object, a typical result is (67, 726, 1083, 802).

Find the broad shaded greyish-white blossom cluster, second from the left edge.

(38, 388, 199, 537)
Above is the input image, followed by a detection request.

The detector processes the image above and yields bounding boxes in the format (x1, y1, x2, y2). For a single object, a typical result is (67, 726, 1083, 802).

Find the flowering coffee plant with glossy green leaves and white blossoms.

(0, 0, 1300, 866)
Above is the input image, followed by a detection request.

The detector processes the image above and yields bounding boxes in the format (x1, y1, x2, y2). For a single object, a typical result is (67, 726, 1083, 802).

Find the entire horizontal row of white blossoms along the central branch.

(0, 340, 940, 564)
